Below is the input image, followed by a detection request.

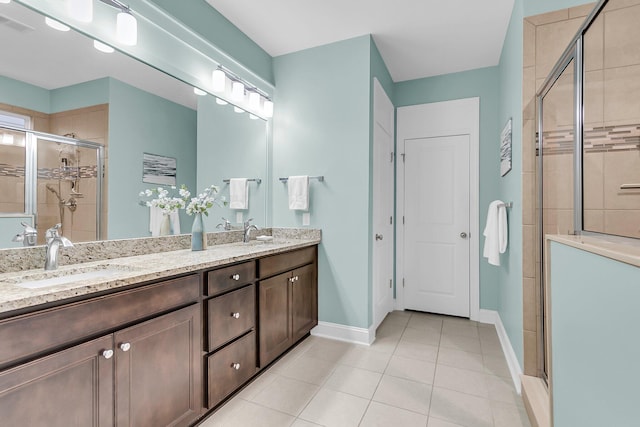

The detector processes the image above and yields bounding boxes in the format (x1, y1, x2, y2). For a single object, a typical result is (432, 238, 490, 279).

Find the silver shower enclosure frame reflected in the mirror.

(0, 125, 105, 240)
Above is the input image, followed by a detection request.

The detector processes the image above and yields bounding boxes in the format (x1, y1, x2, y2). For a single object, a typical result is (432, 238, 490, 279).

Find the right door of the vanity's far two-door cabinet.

(291, 264, 318, 342)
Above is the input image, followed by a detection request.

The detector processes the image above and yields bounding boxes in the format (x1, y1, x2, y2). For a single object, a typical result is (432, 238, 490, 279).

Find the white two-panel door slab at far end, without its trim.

(404, 135, 469, 317)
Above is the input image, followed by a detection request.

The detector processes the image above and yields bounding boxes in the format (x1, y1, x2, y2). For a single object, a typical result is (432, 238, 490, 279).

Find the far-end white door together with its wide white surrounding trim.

(396, 98, 480, 320)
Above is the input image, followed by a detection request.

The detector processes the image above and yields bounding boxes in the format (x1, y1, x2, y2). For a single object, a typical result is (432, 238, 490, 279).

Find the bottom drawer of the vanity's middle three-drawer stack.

(207, 332, 258, 408)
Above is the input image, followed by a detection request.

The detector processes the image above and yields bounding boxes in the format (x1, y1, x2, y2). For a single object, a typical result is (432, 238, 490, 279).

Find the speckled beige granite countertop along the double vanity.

(0, 237, 320, 313)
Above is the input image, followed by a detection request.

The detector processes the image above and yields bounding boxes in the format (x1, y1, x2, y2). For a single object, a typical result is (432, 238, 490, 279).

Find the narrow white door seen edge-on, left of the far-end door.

(372, 79, 395, 328)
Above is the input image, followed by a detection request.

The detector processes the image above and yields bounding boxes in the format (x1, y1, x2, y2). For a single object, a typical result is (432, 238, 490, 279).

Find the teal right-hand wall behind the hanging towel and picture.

(492, 0, 524, 366)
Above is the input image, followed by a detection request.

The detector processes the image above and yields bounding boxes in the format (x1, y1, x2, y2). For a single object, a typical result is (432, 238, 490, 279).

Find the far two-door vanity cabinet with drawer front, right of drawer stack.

(258, 246, 318, 368)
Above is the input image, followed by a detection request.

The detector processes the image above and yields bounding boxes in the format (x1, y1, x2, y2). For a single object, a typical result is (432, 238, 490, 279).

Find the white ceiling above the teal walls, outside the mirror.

(207, 0, 514, 82)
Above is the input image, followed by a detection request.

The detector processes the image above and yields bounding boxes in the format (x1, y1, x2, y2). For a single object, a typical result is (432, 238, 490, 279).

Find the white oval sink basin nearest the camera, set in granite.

(2, 264, 134, 289)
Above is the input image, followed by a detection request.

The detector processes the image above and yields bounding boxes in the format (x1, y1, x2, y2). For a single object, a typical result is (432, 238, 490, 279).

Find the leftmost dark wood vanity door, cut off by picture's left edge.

(0, 335, 113, 427)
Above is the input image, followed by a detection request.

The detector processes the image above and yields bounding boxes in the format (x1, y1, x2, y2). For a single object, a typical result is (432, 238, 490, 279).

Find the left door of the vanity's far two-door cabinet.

(258, 273, 292, 367)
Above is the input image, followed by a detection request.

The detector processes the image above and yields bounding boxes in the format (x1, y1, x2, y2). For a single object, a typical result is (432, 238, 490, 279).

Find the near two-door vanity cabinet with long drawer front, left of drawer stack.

(0, 274, 202, 427)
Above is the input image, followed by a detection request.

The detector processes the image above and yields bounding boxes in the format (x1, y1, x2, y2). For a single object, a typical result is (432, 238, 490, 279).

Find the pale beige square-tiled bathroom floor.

(201, 311, 530, 427)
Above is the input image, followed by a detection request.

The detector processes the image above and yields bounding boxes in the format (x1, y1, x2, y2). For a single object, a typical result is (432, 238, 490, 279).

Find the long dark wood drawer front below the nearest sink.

(0, 274, 200, 367)
